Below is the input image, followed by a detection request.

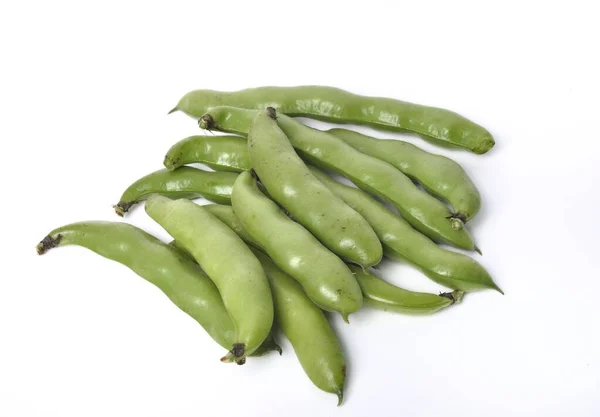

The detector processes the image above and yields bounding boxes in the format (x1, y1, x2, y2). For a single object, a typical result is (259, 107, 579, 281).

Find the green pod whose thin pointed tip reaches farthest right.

(310, 167, 504, 294)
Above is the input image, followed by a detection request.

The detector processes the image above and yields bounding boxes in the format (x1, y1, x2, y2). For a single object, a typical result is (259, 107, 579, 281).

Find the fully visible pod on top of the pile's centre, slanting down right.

(247, 110, 383, 268)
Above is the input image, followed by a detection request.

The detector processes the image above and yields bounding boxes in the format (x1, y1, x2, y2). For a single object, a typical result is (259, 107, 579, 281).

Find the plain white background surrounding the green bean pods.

(0, 0, 600, 417)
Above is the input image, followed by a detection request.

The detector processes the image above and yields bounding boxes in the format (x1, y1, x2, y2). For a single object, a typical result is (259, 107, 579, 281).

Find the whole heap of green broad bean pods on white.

(37, 86, 502, 405)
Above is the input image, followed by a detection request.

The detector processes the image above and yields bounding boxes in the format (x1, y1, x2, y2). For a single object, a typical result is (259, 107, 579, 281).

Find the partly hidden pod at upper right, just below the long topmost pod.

(327, 129, 481, 229)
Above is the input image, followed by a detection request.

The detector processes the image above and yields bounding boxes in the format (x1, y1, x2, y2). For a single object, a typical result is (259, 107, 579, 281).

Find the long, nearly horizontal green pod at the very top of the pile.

(171, 86, 495, 154)
